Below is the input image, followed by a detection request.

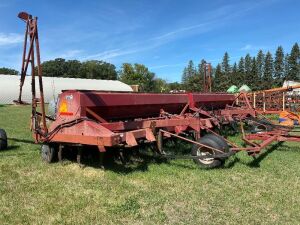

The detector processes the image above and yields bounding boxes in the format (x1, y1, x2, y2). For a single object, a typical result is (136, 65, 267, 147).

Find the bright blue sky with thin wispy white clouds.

(0, 0, 300, 82)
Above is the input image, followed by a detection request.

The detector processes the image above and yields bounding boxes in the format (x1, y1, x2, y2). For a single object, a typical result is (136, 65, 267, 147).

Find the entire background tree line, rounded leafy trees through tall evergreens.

(0, 43, 300, 92)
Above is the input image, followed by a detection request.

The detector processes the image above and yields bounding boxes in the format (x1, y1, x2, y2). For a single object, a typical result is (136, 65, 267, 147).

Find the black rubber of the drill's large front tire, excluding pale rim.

(191, 134, 224, 169)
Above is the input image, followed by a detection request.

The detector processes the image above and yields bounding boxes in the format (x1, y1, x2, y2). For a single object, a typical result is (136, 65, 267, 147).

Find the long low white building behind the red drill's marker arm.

(0, 74, 132, 104)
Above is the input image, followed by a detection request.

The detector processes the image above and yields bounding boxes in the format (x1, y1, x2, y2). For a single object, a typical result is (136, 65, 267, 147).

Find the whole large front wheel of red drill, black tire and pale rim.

(192, 134, 224, 169)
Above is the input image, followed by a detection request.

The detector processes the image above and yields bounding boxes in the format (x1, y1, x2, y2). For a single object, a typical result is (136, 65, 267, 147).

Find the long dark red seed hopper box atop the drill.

(55, 90, 235, 121)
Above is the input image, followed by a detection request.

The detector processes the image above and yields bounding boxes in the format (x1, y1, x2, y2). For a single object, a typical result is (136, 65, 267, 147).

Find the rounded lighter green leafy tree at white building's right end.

(119, 63, 156, 92)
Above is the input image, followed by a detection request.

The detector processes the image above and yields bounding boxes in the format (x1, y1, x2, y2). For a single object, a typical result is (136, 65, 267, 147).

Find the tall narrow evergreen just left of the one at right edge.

(274, 46, 284, 87)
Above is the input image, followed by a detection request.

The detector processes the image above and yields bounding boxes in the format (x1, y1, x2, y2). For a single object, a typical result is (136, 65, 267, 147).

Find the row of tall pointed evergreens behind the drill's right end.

(182, 43, 300, 91)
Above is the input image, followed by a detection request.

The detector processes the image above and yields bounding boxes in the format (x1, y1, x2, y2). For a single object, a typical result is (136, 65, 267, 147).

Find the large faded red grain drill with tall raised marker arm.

(18, 12, 300, 168)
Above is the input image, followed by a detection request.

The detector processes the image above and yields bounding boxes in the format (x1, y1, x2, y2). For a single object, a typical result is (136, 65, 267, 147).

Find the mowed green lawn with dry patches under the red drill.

(0, 106, 300, 224)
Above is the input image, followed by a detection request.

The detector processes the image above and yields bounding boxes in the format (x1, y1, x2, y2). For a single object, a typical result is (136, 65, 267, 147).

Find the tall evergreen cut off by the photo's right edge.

(288, 43, 300, 81)
